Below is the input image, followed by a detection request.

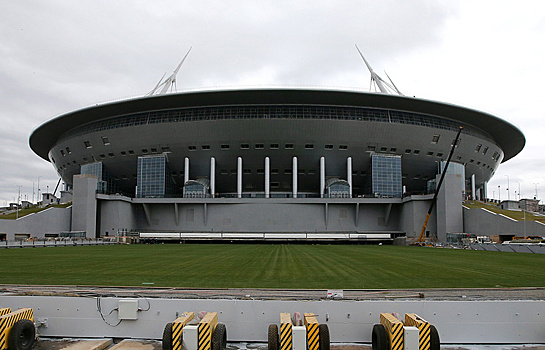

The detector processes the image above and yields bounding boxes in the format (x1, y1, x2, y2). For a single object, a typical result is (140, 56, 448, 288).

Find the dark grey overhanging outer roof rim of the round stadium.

(29, 89, 526, 161)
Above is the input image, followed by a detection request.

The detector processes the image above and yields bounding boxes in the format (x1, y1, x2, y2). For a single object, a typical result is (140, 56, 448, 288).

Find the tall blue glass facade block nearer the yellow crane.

(371, 154, 403, 198)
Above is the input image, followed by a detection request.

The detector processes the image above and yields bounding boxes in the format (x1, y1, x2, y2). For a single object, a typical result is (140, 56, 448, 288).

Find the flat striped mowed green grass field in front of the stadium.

(0, 244, 545, 289)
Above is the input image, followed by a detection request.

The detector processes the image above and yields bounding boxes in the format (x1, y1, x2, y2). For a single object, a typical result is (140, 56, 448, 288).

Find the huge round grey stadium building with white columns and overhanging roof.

(30, 89, 525, 241)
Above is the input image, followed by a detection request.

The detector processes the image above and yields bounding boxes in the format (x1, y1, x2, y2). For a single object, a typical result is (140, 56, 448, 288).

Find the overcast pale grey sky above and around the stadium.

(0, 0, 545, 206)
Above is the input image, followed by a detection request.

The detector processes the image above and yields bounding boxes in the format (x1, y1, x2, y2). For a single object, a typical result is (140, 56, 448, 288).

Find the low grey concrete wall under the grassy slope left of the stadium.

(0, 207, 72, 241)
